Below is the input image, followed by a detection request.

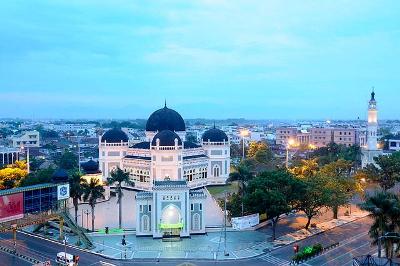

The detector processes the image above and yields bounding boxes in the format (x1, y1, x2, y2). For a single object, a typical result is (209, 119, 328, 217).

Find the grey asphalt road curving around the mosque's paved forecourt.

(0, 218, 376, 266)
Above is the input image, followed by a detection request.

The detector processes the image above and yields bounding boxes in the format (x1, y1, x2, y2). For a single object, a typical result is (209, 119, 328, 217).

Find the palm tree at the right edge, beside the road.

(360, 191, 400, 258)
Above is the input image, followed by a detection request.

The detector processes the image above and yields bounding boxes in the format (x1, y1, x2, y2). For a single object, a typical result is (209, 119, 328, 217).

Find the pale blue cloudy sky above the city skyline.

(0, 0, 400, 119)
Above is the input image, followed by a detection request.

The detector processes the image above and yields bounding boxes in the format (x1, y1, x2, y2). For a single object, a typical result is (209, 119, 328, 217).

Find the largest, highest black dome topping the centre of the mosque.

(146, 106, 186, 131)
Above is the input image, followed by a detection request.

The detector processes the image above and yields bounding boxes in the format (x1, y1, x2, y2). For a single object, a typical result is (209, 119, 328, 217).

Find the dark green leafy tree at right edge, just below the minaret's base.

(367, 152, 400, 190)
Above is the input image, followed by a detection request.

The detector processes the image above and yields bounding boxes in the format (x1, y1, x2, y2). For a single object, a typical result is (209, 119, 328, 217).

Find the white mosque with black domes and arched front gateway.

(99, 104, 230, 238)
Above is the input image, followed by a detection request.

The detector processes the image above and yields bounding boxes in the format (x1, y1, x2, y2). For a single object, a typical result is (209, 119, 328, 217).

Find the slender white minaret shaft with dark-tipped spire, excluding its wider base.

(367, 89, 378, 150)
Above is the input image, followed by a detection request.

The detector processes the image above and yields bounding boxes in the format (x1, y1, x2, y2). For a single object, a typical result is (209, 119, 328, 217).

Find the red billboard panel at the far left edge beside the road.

(0, 193, 24, 222)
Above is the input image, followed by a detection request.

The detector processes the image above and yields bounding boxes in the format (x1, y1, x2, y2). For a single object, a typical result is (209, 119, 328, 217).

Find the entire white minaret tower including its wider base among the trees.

(361, 91, 383, 167)
